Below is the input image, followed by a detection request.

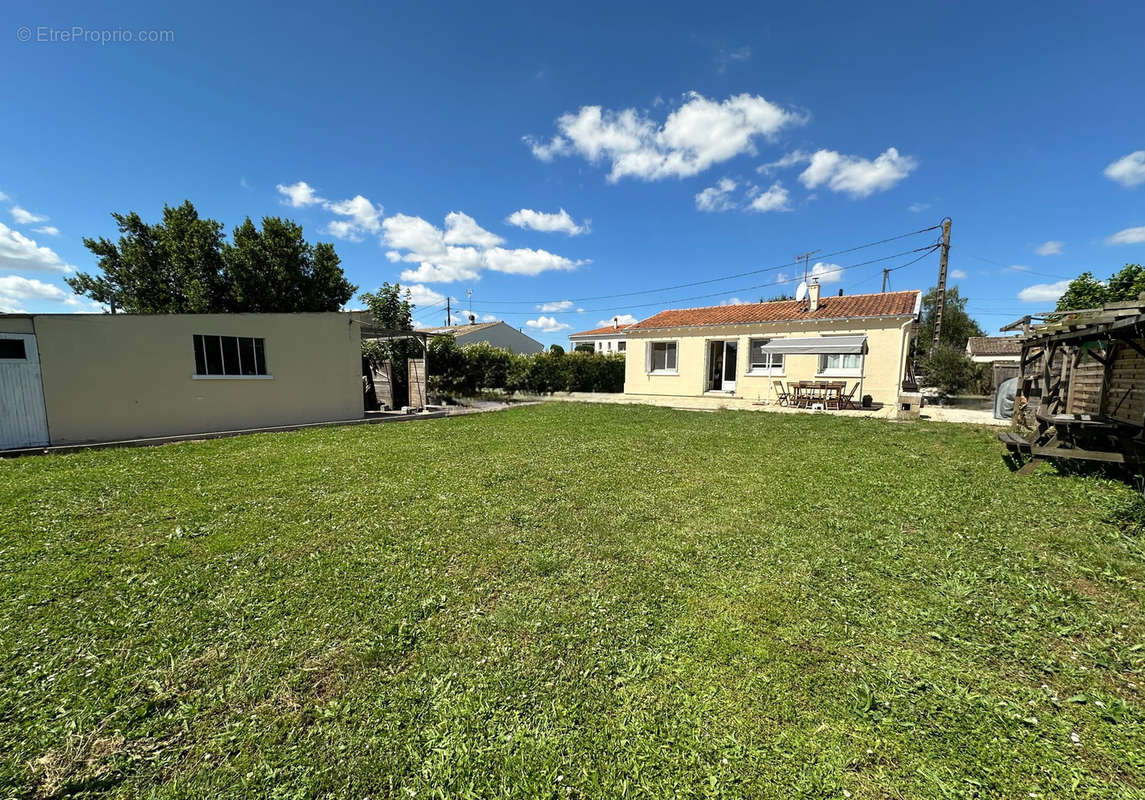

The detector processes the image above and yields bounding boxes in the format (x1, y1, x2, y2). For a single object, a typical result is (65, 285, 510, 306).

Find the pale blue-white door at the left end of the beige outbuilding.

(0, 333, 48, 450)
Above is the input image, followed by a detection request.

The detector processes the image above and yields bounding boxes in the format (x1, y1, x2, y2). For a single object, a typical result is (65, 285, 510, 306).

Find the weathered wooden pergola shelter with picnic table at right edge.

(998, 295, 1145, 474)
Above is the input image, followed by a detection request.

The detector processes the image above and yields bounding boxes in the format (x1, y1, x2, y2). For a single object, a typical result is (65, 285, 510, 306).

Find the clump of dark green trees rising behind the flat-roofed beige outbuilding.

(66, 200, 355, 314)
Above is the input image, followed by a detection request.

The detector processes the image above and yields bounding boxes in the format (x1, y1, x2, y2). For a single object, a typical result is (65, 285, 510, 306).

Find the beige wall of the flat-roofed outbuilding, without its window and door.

(0, 314, 363, 444)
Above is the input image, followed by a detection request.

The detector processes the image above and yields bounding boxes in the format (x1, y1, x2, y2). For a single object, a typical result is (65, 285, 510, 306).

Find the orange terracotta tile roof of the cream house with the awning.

(629, 290, 922, 331)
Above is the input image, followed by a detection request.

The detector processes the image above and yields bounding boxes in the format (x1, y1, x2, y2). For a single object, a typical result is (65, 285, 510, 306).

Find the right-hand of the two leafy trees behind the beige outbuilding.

(223, 216, 357, 312)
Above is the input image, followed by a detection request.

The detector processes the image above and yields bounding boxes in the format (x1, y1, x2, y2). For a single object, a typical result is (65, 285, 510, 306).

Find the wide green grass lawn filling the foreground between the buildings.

(0, 403, 1145, 798)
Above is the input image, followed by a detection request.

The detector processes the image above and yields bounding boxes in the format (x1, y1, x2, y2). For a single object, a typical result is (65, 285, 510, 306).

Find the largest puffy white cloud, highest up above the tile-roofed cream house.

(524, 92, 807, 182)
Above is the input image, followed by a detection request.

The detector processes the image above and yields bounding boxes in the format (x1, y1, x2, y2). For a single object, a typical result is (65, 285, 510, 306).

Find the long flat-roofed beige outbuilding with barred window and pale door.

(0, 312, 363, 450)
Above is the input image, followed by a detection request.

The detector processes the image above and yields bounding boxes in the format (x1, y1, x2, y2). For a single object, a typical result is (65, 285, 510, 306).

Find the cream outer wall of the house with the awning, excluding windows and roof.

(624, 317, 914, 404)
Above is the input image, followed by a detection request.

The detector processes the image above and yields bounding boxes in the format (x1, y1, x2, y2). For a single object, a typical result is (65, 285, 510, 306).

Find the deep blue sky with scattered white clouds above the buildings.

(0, 2, 1145, 342)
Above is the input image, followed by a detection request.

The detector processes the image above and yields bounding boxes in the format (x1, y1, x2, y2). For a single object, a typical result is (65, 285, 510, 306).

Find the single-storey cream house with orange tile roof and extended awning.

(624, 284, 922, 404)
